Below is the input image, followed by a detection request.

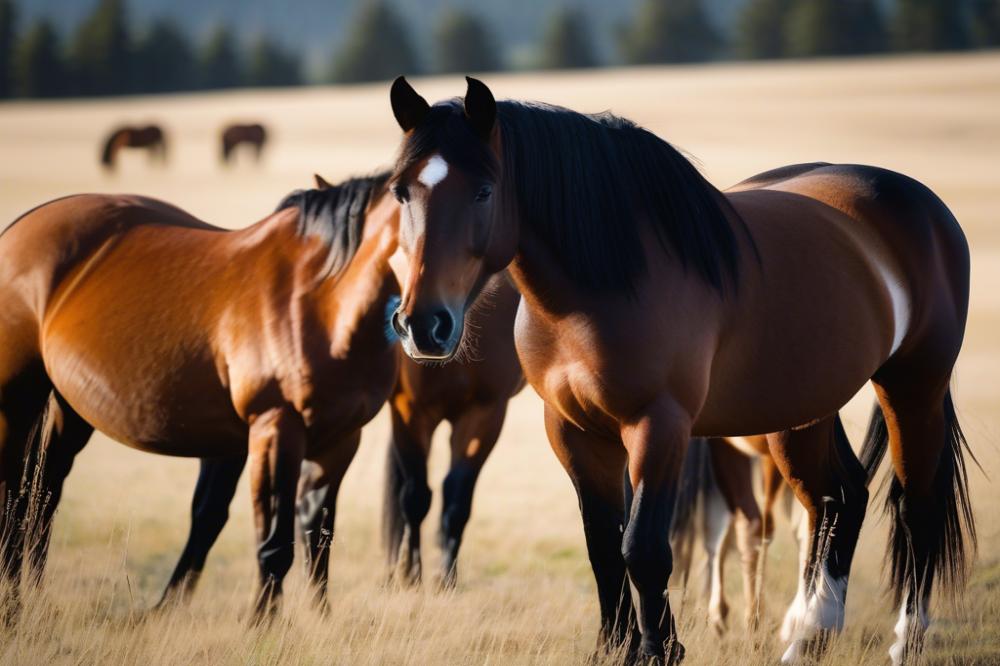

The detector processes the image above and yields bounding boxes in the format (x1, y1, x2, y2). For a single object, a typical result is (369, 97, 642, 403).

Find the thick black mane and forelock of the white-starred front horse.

(396, 100, 739, 294)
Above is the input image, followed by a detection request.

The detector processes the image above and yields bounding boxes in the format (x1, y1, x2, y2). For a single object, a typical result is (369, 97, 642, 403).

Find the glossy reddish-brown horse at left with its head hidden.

(0, 174, 399, 618)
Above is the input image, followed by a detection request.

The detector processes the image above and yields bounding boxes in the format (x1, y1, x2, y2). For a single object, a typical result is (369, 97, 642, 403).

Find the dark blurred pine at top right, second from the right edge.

(893, 0, 969, 51)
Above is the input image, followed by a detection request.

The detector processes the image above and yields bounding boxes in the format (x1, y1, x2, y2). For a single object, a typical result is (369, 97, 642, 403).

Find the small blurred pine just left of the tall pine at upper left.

(12, 20, 68, 97)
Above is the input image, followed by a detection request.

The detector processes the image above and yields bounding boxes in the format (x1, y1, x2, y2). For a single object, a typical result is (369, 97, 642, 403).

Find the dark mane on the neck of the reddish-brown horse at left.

(275, 172, 389, 276)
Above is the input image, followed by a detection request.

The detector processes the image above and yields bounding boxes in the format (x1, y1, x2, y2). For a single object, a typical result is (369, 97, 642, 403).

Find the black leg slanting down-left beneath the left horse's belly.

(157, 456, 247, 608)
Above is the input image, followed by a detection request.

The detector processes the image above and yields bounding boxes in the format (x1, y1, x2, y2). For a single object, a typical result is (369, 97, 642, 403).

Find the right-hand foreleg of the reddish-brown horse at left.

(298, 430, 361, 612)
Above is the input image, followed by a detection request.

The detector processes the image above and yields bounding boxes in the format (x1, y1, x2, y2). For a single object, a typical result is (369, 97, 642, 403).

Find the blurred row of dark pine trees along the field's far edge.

(0, 0, 1000, 98)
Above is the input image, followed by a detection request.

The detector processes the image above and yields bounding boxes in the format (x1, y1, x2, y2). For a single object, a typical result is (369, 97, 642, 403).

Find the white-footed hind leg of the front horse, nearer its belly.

(768, 415, 868, 663)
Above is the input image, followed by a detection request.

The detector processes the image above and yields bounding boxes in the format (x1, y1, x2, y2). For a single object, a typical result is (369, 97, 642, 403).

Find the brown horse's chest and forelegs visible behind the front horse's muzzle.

(382, 274, 524, 587)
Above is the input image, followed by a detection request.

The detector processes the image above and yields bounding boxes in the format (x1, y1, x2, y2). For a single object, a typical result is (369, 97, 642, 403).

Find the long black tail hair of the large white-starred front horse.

(885, 389, 979, 605)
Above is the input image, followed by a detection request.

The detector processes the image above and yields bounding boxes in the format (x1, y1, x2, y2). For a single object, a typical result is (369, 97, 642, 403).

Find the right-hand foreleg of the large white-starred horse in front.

(621, 396, 691, 663)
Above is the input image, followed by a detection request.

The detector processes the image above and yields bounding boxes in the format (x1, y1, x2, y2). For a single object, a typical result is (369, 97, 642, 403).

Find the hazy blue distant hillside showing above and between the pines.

(18, 0, 745, 76)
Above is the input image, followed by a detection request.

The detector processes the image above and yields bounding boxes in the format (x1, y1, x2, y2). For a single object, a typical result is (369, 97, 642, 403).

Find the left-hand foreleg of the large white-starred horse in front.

(545, 407, 636, 656)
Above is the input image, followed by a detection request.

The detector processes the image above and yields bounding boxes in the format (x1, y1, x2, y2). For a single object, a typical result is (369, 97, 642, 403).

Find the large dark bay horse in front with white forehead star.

(390, 77, 975, 663)
